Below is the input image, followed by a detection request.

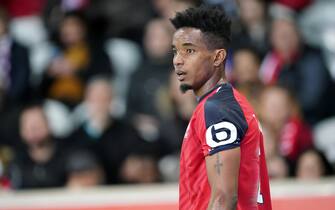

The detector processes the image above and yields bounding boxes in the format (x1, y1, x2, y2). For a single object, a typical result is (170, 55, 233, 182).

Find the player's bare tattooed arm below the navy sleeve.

(206, 147, 241, 210)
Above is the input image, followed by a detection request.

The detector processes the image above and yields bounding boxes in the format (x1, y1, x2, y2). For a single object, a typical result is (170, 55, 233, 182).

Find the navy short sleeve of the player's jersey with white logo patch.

(199, 89, 248, 155)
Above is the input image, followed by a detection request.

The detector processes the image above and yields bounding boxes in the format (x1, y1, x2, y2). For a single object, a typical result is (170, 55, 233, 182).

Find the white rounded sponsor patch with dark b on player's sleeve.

(206, 121, 237, 147)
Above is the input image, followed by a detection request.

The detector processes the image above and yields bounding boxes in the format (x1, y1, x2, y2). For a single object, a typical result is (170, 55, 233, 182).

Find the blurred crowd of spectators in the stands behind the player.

(0, 0, 335, 189)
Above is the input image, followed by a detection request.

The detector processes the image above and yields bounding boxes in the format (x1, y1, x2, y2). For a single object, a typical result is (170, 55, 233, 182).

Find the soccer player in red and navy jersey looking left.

(171, 6, 271, 210)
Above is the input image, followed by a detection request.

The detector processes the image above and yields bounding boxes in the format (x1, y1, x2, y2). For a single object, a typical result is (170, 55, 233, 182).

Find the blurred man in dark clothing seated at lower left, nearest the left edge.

(10, 105, 65, 189)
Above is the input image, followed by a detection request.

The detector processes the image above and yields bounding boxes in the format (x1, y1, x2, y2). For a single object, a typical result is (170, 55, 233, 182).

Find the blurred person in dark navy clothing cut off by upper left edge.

(0, 7, 31, 154)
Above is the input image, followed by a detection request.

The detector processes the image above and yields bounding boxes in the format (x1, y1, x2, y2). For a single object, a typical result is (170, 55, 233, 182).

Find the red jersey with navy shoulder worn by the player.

(179, 84, 272, 210)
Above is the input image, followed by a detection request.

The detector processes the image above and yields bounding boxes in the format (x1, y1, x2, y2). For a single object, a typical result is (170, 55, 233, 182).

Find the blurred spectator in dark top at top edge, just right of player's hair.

(232, 0, 269, 56)
